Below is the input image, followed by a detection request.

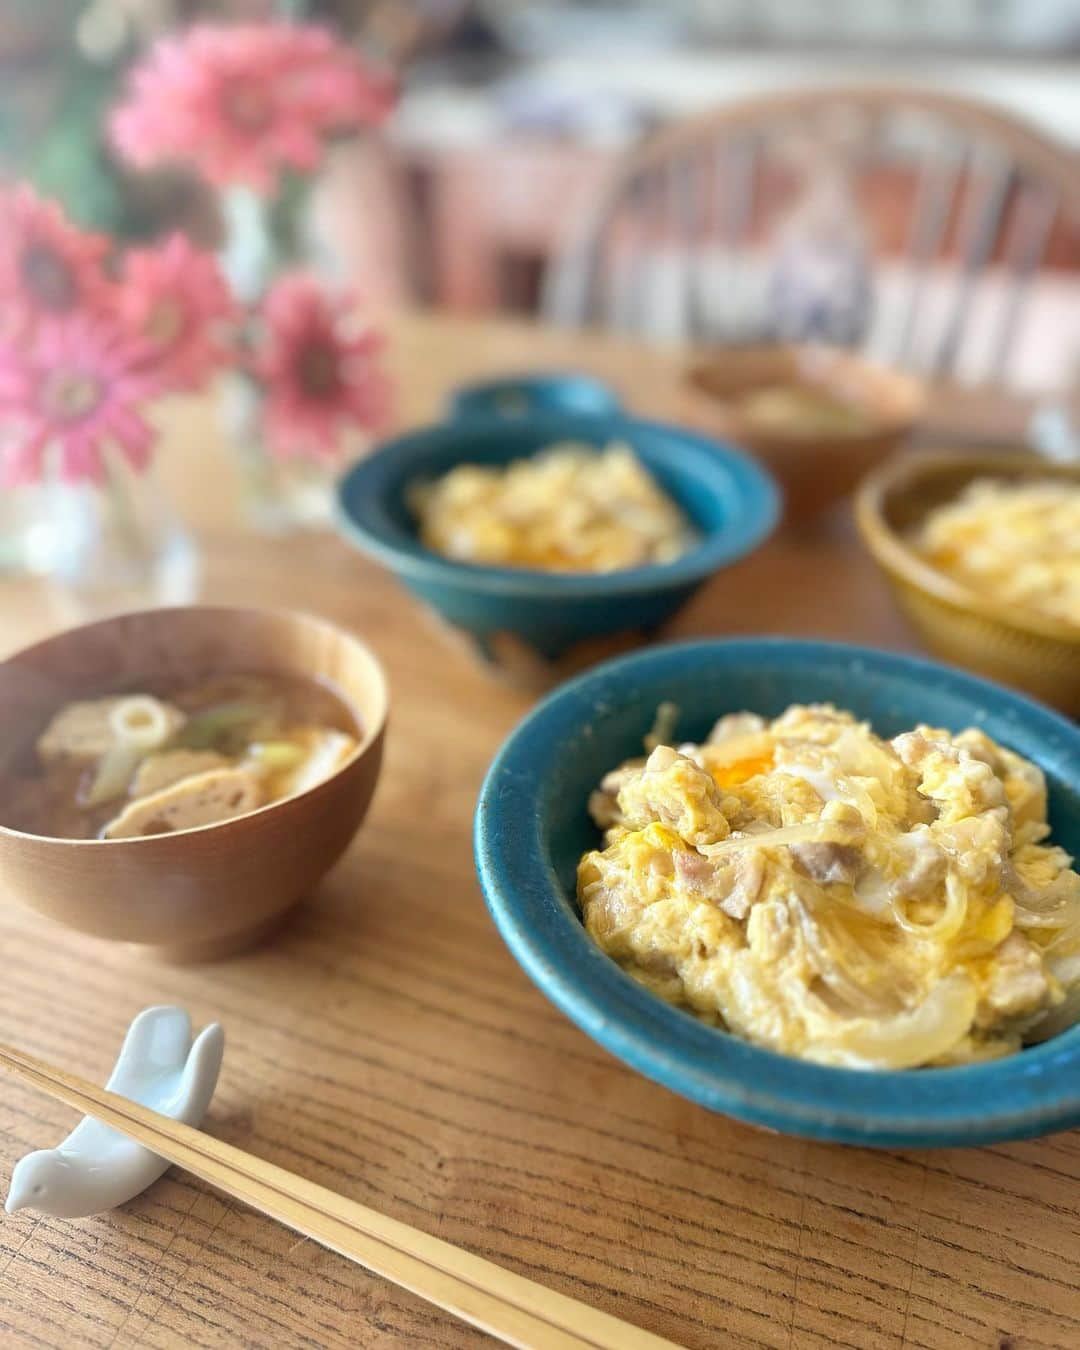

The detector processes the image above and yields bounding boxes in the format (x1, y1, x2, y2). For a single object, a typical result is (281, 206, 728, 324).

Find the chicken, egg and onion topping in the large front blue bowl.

(578, 705, 1080, 1068)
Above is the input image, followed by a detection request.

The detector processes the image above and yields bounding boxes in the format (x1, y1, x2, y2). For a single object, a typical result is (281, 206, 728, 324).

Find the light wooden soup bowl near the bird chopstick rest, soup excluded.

(0, 606, 387, 961)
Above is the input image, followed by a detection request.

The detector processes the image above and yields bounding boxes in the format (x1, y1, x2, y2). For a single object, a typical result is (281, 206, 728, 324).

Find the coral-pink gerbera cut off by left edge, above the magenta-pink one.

(0, 185, 111, 336)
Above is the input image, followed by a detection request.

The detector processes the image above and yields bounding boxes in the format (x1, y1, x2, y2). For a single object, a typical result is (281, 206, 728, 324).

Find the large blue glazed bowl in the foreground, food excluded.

(475, 639, 1080, 1148)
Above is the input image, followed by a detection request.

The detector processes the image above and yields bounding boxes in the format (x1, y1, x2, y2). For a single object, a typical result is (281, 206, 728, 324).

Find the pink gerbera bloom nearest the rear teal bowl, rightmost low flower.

(254, 274, 390, 459)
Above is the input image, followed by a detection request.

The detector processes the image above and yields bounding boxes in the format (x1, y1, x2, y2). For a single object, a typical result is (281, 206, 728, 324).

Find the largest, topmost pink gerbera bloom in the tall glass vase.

(112, 23, 393, 192)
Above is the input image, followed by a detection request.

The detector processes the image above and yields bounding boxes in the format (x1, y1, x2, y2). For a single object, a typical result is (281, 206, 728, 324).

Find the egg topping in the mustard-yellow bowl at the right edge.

(915, 478, 1080, 628)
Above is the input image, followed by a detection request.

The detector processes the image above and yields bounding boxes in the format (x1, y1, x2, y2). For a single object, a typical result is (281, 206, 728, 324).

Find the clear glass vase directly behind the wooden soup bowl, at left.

(26, 466, 200, 621)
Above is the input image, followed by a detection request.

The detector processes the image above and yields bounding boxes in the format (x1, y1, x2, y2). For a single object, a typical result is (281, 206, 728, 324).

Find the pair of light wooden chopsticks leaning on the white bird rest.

(0, 1045, 678, 1350)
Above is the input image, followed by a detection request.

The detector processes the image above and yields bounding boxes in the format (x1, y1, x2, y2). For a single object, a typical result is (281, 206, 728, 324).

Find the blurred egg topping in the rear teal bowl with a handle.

(409, 444, 694, 572)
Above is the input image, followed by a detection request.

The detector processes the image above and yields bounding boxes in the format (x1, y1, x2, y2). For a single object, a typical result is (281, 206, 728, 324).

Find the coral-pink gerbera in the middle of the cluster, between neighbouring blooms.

(119, 234, 234, 389)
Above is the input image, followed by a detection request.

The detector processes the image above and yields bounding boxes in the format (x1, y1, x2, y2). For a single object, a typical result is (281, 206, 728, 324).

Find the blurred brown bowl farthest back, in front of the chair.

(689, 346, 923, 522)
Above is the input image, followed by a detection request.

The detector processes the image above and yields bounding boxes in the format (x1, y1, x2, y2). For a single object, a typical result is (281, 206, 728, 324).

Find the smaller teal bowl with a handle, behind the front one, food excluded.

(339, 375, 779, 675)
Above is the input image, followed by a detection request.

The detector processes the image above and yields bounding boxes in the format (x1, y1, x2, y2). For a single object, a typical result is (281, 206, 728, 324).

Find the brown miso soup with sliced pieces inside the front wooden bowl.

(0, 674, 359, 840)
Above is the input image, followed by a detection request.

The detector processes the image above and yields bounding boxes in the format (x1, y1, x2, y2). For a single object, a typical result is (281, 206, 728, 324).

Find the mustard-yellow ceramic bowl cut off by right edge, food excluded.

(855, 451, 1080, 717)
